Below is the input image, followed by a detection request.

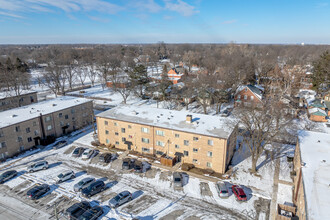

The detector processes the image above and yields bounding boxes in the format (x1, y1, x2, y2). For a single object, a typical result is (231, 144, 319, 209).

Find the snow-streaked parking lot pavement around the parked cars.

(0, 130, 268, 219)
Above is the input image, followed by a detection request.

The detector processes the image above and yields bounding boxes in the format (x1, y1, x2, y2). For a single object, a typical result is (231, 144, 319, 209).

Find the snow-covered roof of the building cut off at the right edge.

(298, 131, 330, 219)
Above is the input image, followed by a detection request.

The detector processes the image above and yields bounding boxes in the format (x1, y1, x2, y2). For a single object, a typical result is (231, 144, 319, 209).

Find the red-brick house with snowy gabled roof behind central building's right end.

(234, 85, 263, 107)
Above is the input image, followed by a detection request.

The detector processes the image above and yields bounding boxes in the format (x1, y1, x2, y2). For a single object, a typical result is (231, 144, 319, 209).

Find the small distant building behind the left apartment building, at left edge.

(0, 90, 38, 111)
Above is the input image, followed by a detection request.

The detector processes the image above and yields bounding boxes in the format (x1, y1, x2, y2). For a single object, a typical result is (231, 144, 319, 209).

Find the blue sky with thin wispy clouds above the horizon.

(0, 0, 330, 44)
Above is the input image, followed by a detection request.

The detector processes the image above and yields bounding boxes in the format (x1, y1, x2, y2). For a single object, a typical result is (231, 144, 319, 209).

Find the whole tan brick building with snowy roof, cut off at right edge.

(293, 131, 330, 220)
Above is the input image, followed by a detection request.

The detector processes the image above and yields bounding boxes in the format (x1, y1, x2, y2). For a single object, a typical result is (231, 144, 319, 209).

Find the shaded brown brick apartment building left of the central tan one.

(0, 96, 93, 159)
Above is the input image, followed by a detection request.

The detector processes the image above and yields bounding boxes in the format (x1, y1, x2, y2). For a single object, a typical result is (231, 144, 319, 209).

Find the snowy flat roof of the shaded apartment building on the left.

(0, 96, 91, 128)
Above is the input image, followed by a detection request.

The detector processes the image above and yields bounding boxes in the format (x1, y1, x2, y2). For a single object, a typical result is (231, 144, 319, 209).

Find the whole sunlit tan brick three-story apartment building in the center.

(96, 105, 237, 173)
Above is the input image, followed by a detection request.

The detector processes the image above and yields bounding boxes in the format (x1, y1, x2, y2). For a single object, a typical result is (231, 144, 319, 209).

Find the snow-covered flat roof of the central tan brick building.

(97, 105, 236, 139)
